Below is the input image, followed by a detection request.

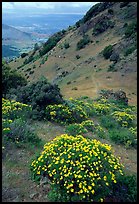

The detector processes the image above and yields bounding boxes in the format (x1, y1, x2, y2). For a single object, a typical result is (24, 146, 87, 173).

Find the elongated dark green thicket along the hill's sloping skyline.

(39, 31, 65, 56)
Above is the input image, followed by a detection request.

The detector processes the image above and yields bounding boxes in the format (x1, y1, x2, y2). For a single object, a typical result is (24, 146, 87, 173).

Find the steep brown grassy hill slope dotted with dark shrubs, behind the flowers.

(10, 2, 137, 104)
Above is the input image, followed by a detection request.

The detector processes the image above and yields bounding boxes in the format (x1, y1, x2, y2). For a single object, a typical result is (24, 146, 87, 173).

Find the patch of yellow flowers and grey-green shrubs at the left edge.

(2, 98, 41, 146)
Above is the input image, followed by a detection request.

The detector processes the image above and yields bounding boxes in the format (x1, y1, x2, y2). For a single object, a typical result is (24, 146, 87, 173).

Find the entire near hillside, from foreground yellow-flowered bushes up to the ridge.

(2, 2, 137, 202)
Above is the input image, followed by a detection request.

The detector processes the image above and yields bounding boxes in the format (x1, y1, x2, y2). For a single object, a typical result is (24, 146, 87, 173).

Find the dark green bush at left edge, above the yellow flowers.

(2, 63, 27, 96)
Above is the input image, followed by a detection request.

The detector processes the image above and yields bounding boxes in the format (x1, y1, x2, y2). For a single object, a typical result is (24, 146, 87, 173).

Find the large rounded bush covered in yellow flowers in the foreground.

(31, 134, 123, 201)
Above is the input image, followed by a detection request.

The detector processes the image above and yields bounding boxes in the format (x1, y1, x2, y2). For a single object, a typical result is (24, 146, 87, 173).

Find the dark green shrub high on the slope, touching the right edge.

(125, 21, 137, 38)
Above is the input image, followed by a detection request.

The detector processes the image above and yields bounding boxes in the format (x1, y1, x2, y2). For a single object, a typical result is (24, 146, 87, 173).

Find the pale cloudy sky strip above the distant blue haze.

(2, 2, 98, 14)
